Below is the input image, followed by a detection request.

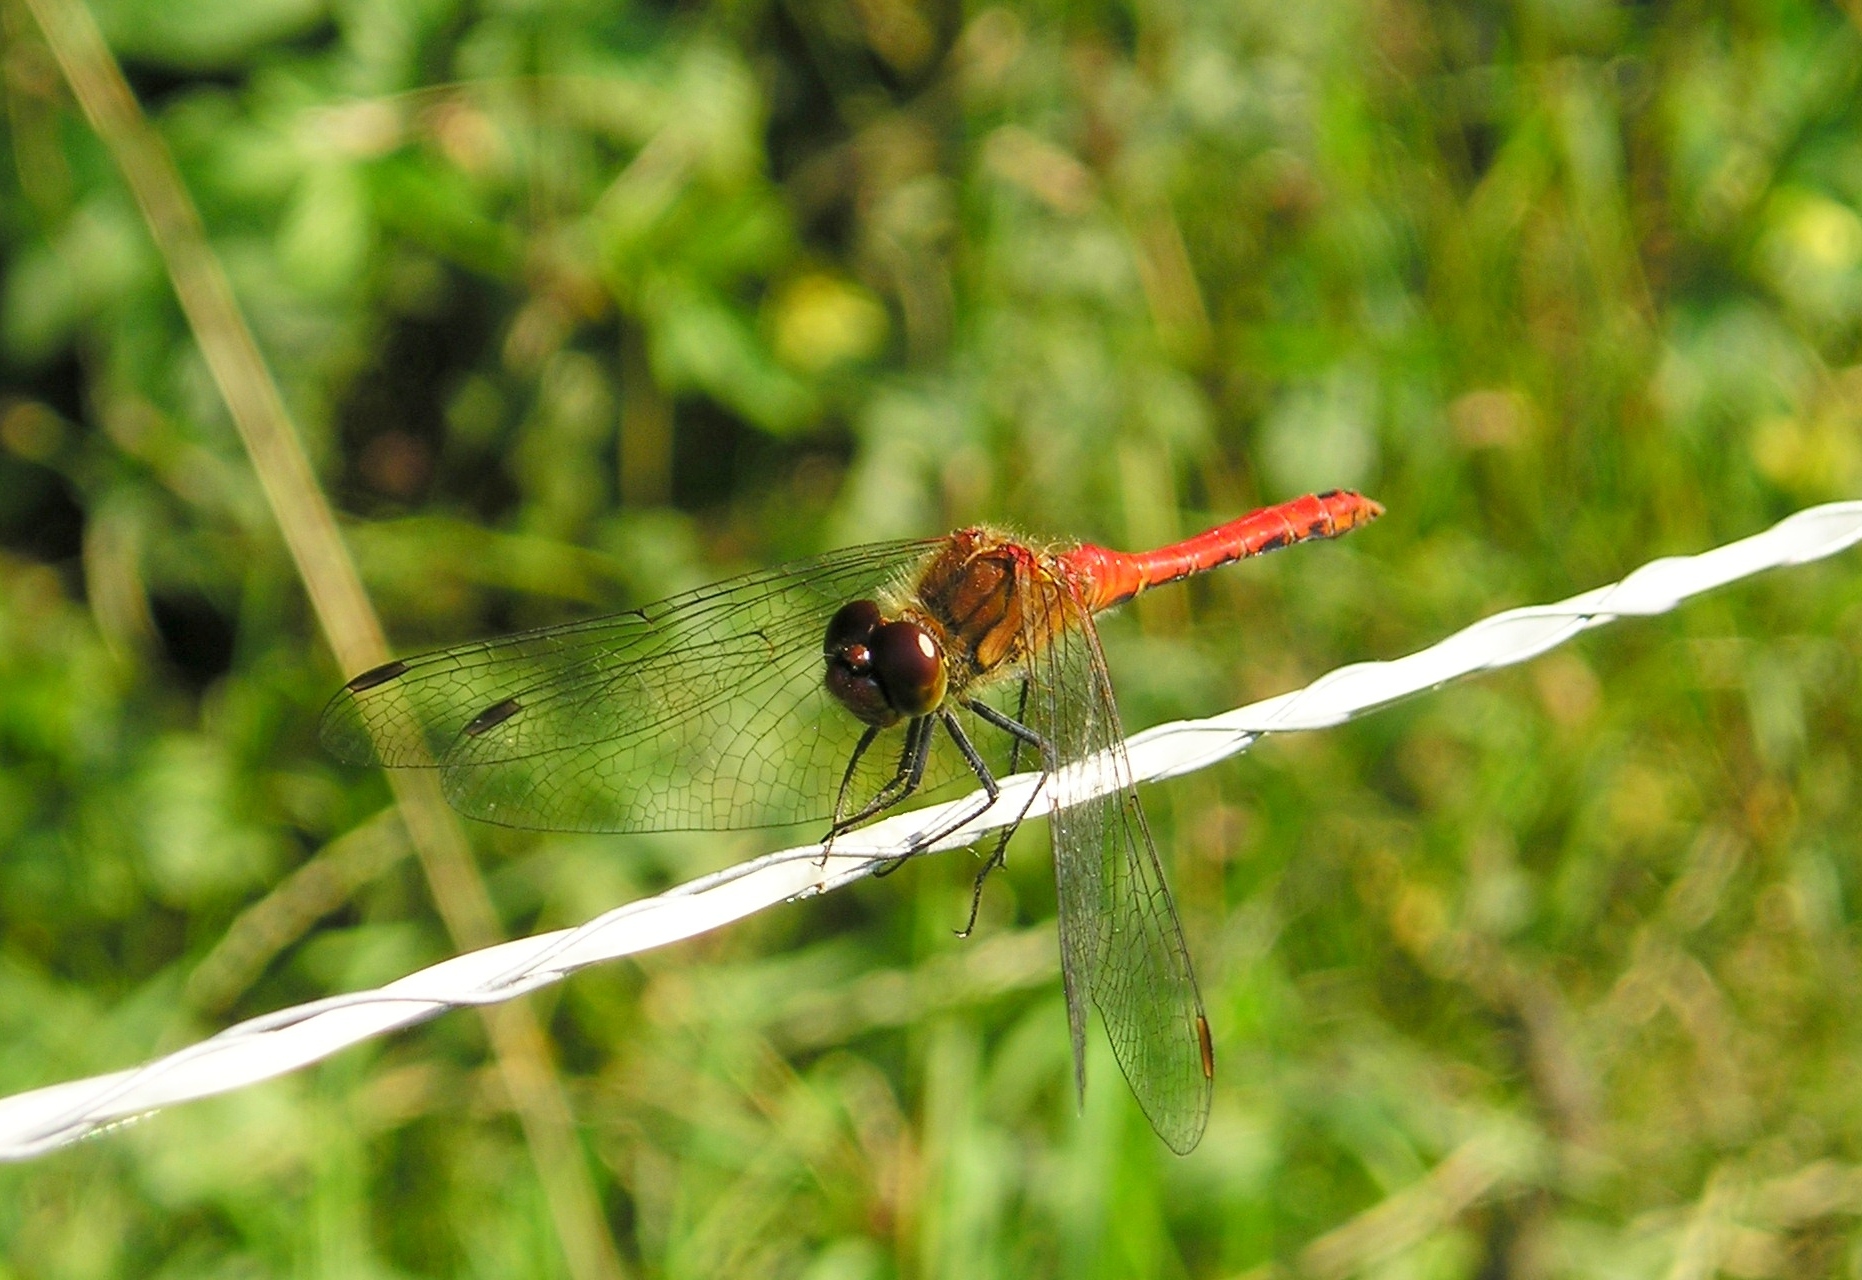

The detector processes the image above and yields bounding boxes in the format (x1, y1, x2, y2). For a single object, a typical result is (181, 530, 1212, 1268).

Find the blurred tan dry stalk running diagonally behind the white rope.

(26, 0, 622, 1280)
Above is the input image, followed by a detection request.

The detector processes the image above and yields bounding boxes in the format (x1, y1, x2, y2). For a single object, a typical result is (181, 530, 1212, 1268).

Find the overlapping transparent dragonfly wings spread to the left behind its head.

(322, 542, 937, 831)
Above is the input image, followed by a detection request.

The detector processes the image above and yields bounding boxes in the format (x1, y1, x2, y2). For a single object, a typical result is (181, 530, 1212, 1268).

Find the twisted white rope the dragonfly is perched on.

(0, 501, 1862, 1161)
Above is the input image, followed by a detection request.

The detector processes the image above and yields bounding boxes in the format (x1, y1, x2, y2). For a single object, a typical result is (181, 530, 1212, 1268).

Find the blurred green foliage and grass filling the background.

(0, 0, 1862, 1280)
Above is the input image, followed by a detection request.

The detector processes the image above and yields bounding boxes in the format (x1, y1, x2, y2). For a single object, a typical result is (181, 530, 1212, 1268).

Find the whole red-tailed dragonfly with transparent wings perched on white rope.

(320, 490, 1383, 1153)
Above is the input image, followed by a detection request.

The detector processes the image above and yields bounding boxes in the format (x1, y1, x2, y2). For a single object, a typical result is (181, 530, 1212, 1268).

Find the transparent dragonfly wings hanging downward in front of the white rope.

(1028, 576, 1214, 1153)
